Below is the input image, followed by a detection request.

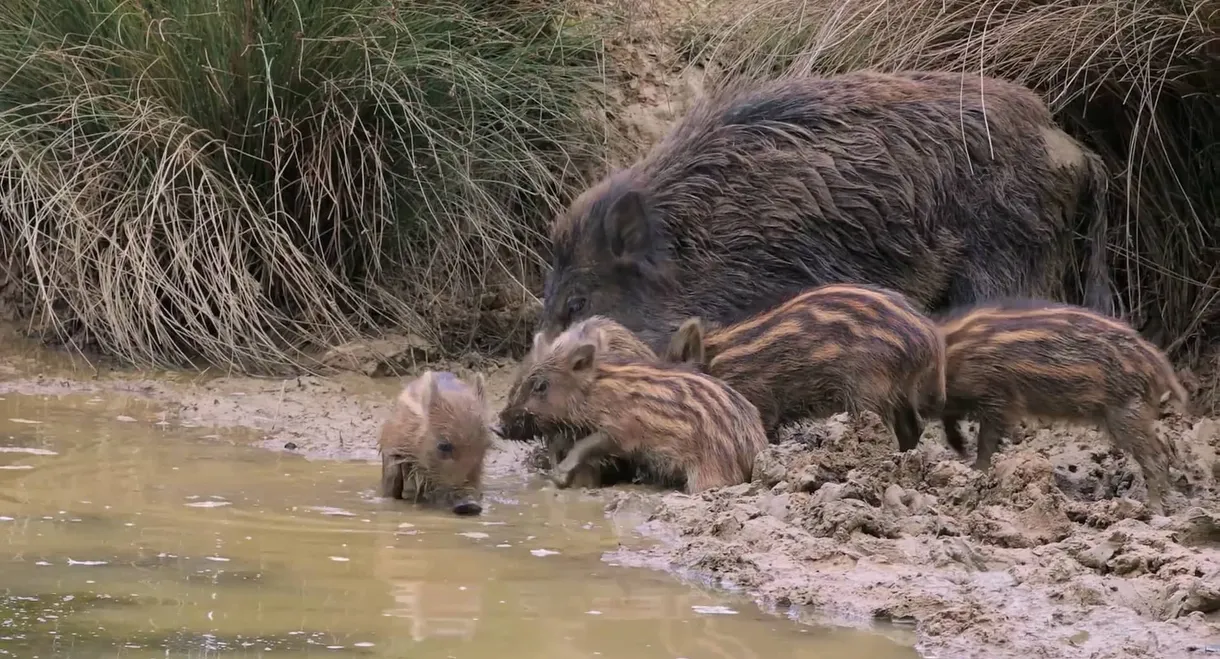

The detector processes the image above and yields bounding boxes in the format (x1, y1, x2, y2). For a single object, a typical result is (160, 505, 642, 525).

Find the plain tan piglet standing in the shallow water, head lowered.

(378, 371, 492, 515)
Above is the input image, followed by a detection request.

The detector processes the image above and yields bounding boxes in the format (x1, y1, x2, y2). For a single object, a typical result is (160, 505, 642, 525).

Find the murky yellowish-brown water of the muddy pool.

(0, 388, 915, 659)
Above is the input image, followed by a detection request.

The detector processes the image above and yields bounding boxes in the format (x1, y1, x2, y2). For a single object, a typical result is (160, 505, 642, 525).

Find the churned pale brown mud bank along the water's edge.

(0, 346, 1220, 659)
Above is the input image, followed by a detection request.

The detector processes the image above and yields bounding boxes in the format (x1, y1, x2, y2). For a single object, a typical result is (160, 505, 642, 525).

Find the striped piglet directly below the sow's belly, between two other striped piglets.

(665, 284, 944, 450)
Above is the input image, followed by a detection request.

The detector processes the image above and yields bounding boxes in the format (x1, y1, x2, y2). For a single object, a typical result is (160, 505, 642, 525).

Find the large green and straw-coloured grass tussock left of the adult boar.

(0, 0, 601, 370)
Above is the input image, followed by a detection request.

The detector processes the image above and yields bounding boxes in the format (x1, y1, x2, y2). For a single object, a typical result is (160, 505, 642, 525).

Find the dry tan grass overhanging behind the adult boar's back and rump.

(684, 0, 1220, 356)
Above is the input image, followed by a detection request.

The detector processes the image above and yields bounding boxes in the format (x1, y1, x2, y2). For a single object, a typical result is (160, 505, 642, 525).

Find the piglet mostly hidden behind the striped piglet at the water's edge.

(499, 316, 656, 487)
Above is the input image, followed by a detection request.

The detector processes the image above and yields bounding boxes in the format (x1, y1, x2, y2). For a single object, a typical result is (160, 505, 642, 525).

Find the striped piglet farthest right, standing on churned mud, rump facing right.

(941, 300, 1190, 513)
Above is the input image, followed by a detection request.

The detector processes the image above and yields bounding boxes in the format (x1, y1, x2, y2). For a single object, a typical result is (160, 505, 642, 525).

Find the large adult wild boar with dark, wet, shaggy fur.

(539, 72, 1111, 351)
